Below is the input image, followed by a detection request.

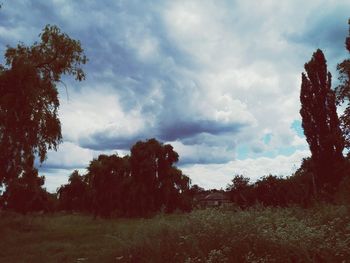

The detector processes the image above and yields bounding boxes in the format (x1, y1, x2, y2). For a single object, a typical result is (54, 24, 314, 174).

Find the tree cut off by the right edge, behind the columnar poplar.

(336, 19, 350, 148)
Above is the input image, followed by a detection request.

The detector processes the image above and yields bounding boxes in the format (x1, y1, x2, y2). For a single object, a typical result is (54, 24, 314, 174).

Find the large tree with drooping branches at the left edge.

(0, 25, 87, 189)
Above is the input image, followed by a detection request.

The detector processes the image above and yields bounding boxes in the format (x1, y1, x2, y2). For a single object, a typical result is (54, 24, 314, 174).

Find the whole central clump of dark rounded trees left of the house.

(58, 139, 191, 217)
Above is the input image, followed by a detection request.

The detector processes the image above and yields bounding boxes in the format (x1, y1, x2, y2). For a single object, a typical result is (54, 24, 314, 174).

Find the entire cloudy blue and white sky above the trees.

(0, 0, 350, 191)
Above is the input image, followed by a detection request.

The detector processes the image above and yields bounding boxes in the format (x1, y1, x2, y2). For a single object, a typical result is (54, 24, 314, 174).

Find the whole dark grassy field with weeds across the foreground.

(0, 205, 350, 263)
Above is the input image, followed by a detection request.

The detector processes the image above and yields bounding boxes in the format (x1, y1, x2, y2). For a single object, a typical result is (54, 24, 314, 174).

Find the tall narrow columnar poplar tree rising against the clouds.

(300, 49, 344, 190)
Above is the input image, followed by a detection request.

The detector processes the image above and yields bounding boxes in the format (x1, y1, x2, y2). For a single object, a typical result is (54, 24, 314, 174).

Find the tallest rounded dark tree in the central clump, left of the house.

(130, 139, 190, 215)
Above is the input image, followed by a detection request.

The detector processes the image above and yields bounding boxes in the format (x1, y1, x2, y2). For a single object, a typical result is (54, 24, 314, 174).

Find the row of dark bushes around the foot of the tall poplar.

(226, 157, 350, 208)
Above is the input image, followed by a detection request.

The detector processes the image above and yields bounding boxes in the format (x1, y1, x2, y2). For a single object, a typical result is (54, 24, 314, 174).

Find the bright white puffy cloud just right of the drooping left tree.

(59, 87, 148, 142)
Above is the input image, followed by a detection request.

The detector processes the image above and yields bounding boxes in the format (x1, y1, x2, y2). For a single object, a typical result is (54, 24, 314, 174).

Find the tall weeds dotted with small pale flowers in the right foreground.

(125, 205, 350, 262)
